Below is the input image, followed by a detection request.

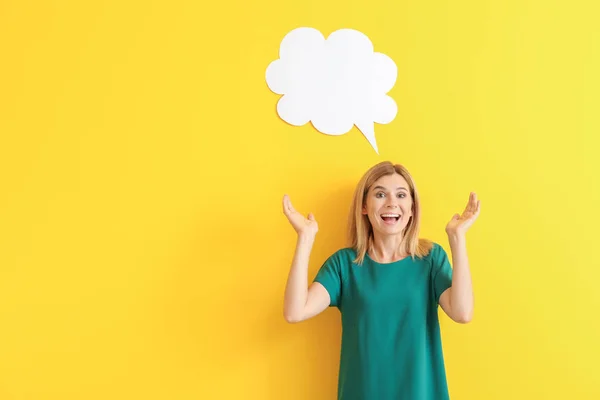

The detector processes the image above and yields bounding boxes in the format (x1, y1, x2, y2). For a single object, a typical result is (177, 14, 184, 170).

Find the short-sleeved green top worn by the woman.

(314, 243, 452, 400)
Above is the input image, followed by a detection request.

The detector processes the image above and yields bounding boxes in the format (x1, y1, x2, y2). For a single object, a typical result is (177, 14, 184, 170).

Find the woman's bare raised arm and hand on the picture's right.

(440, 193, 480, 323)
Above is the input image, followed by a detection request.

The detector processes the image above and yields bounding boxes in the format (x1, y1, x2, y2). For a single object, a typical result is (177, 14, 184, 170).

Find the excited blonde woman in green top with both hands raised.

(283, 162, 480, 400)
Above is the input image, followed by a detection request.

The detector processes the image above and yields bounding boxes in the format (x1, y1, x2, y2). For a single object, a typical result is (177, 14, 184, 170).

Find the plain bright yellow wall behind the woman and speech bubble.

(0, 0, 600, 400)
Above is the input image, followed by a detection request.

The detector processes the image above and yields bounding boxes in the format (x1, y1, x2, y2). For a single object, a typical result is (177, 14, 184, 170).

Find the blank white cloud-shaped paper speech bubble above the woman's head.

(266, 28, 398, 154)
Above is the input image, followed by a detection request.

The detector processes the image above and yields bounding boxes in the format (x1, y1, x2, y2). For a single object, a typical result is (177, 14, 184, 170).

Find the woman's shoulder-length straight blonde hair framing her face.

(348, 161, 433, 264)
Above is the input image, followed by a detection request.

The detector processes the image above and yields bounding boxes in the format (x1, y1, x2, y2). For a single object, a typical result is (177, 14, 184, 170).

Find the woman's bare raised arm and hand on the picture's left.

(283, 196, 330, 323)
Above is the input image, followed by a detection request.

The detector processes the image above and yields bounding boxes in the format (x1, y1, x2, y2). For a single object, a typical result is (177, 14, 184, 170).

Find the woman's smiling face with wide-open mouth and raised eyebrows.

(362, 174, 413, 235)
